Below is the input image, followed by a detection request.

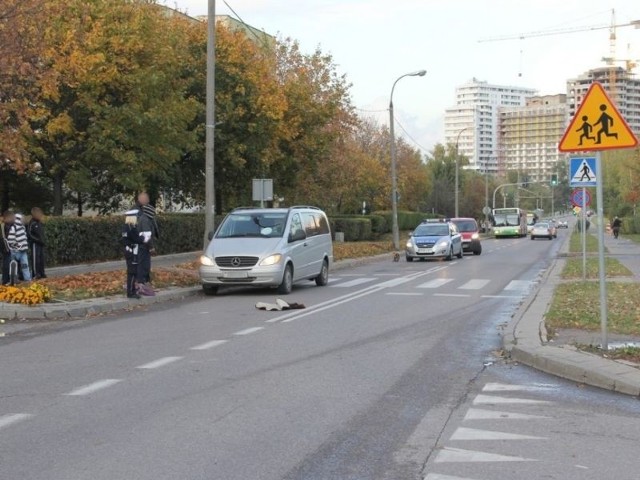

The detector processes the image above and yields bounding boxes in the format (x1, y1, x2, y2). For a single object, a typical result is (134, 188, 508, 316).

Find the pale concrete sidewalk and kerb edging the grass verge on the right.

(503, 220, 640, 396)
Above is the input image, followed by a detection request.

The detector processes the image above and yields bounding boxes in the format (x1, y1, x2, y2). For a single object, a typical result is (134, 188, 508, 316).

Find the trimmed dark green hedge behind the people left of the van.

(46, 213, 223, 266)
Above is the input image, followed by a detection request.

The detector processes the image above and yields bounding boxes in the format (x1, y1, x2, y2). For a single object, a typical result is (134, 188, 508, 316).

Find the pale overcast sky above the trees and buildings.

(166, 0, 640, 153)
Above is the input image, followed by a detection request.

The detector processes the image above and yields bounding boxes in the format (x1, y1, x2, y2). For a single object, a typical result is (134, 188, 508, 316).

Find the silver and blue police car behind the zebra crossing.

(405, 220, 464, 262)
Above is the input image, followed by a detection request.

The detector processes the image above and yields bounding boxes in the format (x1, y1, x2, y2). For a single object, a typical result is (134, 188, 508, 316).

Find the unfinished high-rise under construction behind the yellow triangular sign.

(567, 67, 640, 135)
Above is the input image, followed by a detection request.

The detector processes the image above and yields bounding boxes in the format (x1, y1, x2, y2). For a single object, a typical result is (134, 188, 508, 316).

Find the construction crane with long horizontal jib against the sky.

(478, 10, 640, 99)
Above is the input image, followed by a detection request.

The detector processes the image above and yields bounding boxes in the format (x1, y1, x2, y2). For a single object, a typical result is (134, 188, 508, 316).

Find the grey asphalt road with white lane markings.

(0, 231, 640, 480)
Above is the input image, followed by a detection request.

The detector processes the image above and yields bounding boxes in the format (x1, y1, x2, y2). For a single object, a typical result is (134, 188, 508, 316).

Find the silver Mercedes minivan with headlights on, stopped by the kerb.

(200, 207, 333, 295)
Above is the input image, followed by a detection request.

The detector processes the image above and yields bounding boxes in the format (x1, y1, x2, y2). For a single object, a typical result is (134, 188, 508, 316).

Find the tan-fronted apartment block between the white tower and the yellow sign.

(498, 94, 568, 182)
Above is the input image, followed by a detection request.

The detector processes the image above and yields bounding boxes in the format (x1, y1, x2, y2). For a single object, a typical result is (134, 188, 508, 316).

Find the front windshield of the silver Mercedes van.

(215, 212, 287, 238)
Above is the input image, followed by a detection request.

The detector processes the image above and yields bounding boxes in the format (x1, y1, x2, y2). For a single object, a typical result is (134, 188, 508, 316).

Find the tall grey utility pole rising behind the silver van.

(204, 0, 216, 248)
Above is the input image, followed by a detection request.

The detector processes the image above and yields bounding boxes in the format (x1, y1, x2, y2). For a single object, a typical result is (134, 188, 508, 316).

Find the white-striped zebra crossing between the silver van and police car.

(329, 276, 536, 298)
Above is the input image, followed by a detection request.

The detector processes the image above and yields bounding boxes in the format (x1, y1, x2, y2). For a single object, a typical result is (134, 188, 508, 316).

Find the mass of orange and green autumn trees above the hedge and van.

(0, 0, 429, 214)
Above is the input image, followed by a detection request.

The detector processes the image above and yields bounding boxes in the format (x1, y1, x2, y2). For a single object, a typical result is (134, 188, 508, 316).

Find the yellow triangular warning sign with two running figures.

(558, 82, 638, 152)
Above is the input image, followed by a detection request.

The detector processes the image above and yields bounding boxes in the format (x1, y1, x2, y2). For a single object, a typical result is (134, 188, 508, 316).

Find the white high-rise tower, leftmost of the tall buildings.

(444, 78, 536, 174)
